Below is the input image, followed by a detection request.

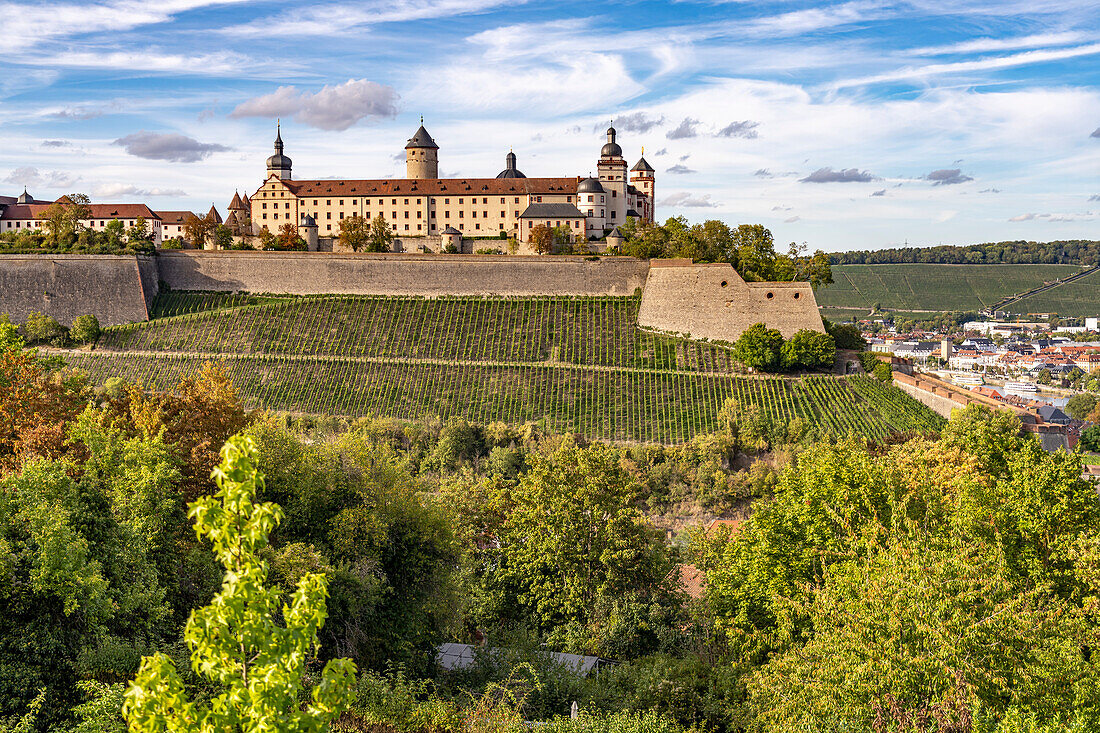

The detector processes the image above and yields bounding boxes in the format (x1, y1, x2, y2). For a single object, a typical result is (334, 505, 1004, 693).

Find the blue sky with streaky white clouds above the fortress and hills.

(0, 0, 1100, 251)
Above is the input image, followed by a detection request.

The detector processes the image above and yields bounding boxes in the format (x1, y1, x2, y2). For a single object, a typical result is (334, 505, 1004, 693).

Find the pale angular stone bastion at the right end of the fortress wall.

(638, 260, 825, 342)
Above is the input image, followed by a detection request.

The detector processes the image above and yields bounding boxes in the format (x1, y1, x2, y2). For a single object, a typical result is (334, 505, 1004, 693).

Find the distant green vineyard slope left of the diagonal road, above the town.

(816, 264, 1082, 314)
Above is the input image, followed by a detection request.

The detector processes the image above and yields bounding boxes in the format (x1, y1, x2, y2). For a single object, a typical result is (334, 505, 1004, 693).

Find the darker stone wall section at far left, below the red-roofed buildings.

(0, 254, 156, 326)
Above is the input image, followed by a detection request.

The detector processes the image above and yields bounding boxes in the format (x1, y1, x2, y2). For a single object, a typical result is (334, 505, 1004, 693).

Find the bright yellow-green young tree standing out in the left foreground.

(124, 437, 355, 733)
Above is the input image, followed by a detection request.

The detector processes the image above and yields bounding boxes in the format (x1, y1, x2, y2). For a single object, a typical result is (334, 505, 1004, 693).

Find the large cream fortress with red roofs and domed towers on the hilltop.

(251, 119, 655, 249)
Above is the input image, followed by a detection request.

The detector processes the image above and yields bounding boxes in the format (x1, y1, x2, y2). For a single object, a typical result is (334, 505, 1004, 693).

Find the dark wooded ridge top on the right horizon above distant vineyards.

(829, 239, 1100, 265)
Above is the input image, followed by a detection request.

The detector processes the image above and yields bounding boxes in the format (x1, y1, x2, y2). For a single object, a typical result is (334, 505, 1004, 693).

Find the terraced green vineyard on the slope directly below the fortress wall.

(75, 293, 943, 444)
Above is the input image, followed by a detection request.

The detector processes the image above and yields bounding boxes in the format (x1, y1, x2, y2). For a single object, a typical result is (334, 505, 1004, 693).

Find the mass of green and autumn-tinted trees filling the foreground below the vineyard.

(0, 314, 1100, 733)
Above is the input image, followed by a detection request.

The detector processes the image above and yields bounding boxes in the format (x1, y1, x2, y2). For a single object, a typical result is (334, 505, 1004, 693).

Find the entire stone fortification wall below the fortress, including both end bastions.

(0, 252, 823, 341)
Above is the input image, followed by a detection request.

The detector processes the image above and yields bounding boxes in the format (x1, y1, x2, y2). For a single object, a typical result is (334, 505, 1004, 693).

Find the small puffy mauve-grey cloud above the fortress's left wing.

(229, 79, 398, 130)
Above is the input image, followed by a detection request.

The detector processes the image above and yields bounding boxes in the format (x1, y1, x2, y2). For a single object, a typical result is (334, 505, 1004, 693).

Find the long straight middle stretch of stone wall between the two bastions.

(157, 251, 646, 297)
